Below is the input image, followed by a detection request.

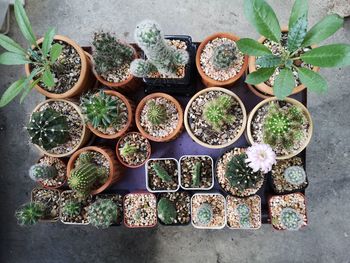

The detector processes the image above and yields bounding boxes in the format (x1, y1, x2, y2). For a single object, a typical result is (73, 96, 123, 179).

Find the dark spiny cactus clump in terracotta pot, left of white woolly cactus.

(92, 31, 139, 91)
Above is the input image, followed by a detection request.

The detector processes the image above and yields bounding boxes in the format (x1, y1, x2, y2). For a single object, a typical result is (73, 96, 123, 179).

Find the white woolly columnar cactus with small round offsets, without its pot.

(130, 20, 189, 78)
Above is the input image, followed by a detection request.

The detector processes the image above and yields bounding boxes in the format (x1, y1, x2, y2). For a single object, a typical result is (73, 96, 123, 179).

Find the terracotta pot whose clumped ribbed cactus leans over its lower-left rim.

(67, 146, 123, 195)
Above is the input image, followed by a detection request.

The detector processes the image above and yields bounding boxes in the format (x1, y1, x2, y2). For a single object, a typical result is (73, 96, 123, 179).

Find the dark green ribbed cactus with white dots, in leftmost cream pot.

(27, 108, 69, 150)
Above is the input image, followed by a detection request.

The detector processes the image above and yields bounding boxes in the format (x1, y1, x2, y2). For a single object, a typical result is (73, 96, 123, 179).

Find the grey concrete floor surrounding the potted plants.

(0, 0, 350, 263)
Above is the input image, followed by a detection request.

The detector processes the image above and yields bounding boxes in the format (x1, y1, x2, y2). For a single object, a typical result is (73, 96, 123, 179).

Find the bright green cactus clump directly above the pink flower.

(263, 103, 306, 150)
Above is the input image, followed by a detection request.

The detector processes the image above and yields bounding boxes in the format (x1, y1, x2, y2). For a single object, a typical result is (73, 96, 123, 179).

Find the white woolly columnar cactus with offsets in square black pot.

(130, 20, 196, 95)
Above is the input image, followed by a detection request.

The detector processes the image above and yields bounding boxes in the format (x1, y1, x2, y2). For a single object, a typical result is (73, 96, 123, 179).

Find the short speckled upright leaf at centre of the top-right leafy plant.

(287, 15, 307, 53)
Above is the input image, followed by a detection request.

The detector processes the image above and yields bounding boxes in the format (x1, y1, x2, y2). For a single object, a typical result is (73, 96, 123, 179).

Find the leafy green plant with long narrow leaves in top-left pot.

(0, 0, 63, 107)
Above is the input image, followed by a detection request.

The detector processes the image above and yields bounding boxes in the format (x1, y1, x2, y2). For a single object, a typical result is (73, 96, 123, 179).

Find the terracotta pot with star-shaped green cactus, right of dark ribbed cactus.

(80, 90, 135, 139)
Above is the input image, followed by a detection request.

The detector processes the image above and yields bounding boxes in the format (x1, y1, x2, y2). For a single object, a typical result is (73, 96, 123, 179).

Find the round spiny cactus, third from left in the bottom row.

(88, 199, 118, 228)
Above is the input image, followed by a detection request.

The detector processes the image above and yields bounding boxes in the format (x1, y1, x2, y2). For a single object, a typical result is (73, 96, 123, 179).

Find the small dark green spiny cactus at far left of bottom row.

(15, 202, 45, 226)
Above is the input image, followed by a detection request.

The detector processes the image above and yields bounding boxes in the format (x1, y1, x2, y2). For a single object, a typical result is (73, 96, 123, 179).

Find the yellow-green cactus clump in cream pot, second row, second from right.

(203, 95, 235, 131)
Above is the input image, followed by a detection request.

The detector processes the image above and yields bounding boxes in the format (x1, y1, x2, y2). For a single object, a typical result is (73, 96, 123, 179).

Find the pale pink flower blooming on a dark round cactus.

(245, 143, 276, 174)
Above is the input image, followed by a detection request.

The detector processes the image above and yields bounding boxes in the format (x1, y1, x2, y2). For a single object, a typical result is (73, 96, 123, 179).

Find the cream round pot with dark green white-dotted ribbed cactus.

(27, 99, 90, 158)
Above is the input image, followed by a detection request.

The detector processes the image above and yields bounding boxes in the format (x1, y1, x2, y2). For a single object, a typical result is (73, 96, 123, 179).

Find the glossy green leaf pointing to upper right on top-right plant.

(302, 14, 344, 47)
